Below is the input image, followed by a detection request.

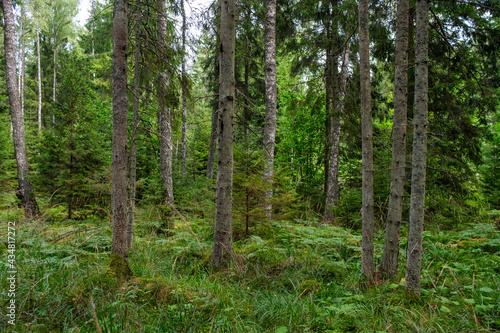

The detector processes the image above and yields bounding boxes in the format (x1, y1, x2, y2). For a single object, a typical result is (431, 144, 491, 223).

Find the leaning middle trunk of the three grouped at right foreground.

(380, 0, 410, 278)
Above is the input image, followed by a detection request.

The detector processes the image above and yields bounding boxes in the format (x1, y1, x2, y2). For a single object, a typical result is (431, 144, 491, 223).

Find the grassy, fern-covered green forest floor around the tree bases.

(0, 197, 500, 333)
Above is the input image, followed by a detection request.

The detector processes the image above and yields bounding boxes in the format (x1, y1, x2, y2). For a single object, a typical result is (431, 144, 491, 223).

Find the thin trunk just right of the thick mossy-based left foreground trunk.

(127, 19, 141, 249)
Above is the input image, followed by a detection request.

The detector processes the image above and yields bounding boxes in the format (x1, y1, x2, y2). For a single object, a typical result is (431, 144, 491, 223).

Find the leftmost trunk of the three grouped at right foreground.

(359, 0, 374, 281)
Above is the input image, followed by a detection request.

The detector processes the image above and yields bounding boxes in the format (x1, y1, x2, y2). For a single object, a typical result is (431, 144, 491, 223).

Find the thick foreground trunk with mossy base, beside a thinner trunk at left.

(110, 0, 132, 279)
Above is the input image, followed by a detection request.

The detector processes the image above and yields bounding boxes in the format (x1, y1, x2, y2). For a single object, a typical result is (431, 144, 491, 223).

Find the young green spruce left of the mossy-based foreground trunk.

(35, 53, 111, 218)
